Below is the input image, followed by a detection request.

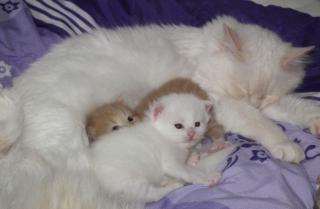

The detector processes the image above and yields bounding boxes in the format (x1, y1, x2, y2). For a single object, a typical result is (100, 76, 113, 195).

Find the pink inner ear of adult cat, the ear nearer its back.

(222, 23, 244, 60)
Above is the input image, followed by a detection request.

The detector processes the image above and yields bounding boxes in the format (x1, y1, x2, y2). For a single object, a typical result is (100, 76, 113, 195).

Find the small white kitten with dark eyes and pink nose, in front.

(92, 94, 217, 203)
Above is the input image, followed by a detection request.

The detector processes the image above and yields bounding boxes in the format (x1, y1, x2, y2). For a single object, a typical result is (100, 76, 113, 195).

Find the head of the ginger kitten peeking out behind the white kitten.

(86, 100, 140, 143)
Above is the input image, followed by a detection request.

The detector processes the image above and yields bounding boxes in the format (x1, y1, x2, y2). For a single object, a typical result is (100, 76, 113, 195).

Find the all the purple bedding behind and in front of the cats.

(0, 0, 320, 209)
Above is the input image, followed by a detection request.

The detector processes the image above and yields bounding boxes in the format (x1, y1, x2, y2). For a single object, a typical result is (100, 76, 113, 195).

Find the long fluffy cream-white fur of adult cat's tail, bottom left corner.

(0, 153, 144, 209)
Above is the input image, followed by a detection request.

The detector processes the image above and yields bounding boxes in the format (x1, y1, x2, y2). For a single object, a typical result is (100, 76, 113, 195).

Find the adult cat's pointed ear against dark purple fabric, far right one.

(281, 46, 314, 69)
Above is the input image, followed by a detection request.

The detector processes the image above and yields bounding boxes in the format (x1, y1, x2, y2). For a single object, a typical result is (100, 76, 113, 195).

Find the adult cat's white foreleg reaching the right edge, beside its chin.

(262, 95, 320, 136)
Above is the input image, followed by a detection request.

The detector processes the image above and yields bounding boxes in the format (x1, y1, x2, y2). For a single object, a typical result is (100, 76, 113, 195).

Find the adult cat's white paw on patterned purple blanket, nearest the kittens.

(270, 141, 305, 163)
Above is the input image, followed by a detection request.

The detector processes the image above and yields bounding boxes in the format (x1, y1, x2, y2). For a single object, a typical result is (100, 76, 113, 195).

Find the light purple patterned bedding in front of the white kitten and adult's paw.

(147, 119, 320, 209)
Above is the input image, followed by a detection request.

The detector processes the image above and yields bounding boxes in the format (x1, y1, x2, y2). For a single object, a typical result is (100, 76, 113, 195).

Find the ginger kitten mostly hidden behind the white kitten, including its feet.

(86, 78, 228, 168)
